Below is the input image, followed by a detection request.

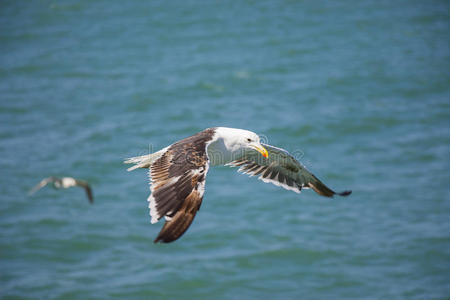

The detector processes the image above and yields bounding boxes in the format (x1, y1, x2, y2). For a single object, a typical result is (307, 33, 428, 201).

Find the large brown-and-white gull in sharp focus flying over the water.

(125, 127, 351, 243)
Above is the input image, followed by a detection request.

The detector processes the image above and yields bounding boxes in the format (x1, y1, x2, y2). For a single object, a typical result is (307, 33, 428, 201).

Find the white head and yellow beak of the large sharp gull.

(216, 127, 269, 158)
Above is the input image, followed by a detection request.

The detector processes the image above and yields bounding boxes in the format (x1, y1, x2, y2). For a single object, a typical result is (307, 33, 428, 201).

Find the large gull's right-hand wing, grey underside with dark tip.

(227, 144, 351, 197)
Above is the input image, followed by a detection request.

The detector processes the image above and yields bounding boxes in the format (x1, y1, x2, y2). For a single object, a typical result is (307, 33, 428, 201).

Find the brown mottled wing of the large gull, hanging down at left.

(148, 132, 211, 243)
